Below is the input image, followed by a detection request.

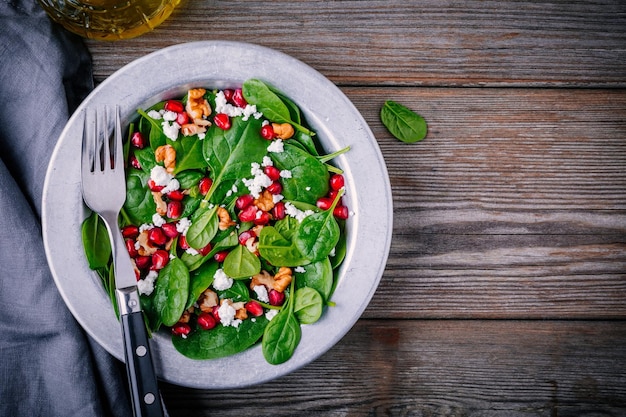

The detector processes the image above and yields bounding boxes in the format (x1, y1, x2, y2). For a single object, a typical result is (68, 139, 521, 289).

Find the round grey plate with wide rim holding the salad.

(43, 41, 392, 389)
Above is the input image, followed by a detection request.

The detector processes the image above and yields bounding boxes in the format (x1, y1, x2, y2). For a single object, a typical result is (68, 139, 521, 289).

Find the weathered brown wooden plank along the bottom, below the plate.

(158, 320, 626, 417)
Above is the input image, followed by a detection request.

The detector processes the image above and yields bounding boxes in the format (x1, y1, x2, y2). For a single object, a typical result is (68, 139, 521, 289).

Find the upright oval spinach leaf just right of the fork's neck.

(153, 258, 189, 326)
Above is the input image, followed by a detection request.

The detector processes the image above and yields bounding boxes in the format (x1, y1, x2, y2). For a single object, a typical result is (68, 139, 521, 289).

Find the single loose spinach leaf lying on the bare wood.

(380, 100, 428, 143)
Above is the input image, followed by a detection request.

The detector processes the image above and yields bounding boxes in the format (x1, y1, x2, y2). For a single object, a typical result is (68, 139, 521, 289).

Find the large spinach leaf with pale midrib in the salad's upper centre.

(202, 117, 267, 203)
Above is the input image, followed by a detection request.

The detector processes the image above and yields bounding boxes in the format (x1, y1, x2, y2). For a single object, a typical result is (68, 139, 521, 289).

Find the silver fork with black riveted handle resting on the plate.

(81, 106, 163, 417)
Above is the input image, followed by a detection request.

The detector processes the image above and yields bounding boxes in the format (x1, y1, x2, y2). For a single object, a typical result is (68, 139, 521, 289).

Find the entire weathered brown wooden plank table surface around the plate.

(88, 0, 626, 417)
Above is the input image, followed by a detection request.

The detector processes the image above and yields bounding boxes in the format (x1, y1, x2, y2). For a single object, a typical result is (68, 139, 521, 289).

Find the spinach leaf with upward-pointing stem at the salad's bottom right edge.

(261, 281, 302, 365)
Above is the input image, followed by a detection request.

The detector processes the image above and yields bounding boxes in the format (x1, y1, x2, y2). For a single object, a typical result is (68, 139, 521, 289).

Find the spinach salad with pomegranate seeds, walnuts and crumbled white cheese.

(82, 79, 350, 364)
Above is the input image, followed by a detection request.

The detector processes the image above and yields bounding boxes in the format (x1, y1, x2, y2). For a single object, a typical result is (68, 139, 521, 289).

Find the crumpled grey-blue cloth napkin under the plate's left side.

(0, 0, 132, 417)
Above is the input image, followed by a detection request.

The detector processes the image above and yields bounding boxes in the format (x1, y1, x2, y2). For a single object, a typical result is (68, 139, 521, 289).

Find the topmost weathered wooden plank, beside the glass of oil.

(88, 0, 626, 86)
